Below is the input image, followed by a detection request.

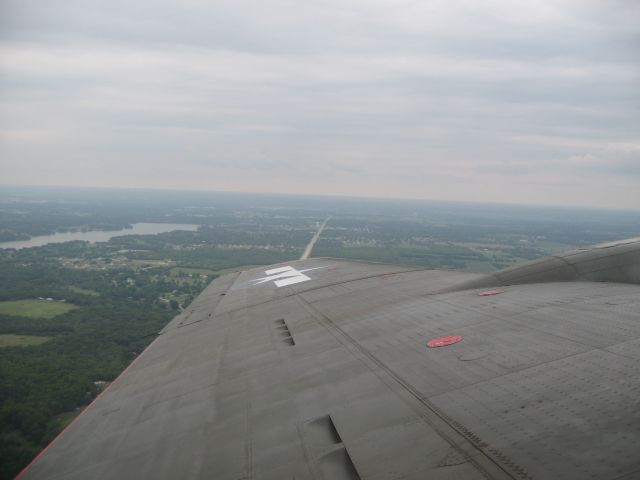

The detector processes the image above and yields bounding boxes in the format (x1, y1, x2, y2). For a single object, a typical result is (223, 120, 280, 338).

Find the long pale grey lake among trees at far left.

(0, 223, 199, 250)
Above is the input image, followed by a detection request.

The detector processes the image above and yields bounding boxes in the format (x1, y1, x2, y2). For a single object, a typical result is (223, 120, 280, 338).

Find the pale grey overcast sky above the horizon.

(0, 0, 640, 209)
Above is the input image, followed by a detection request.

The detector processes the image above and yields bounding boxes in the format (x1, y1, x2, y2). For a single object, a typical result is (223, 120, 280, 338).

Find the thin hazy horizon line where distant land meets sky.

(0, 183, 640, 213)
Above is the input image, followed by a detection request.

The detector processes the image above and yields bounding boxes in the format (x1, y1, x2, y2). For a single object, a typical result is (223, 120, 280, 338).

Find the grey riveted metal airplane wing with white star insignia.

(19, 239, 640, 480)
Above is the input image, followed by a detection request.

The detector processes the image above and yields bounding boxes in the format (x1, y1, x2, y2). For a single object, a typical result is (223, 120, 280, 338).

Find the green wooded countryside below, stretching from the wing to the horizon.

(0, 187, 640, 478)
